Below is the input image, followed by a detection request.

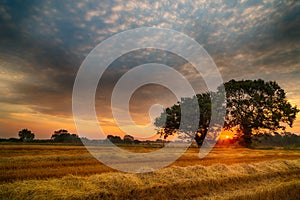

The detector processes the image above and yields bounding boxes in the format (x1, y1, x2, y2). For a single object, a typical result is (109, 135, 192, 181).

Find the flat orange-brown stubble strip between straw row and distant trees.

(0, 145, 300, 183)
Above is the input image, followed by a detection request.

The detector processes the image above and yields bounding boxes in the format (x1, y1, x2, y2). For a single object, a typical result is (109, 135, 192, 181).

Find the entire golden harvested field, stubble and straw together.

(0, 145, 300, 200)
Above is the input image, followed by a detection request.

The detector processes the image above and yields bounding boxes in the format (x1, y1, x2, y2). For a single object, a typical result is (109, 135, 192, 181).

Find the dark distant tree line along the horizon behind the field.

(0, 129, 300, 148)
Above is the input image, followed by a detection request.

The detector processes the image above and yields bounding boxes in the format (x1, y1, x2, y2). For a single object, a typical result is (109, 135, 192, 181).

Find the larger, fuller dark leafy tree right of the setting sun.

(224, 79, 299, 147)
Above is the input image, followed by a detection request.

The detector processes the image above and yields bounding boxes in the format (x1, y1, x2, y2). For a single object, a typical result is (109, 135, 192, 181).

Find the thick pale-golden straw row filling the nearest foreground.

(0, 160, 300, 200)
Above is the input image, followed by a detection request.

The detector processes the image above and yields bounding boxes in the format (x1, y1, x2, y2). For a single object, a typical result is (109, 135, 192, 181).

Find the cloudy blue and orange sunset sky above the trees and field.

(0, 0, 300, 138)
